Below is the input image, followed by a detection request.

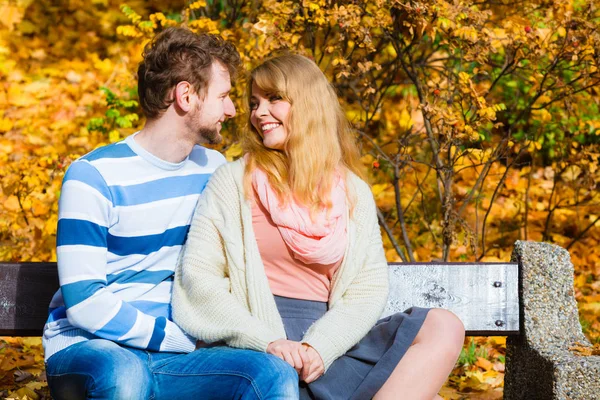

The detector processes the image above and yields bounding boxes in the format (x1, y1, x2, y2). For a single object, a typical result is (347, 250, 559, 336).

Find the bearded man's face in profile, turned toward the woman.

(186, 62, 235, 144)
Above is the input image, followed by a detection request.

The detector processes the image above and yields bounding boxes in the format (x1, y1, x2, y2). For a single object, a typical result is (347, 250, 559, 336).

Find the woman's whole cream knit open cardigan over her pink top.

(172, 159, 388, 369)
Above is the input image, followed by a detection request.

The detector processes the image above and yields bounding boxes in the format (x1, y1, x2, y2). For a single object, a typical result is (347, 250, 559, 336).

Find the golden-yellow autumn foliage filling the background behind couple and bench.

(0, 0, 600, 398)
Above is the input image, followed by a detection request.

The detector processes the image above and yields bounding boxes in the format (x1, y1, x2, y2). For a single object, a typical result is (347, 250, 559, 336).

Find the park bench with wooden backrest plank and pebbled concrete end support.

(0, 241, 600, 400)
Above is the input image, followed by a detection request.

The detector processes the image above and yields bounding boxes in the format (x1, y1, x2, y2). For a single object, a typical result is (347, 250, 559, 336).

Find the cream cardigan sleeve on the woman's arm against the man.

(172, 167, 281, 352)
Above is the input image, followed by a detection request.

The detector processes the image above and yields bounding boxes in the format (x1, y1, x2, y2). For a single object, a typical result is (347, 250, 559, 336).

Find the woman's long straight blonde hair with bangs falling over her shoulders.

(241, 54, 364, 211)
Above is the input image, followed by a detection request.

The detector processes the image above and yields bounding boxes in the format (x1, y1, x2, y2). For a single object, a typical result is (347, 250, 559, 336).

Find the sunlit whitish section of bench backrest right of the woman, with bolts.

(383, 263, 519, 336)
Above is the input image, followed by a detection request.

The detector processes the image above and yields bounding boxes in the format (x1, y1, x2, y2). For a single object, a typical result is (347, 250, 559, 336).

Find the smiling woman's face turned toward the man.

(250, 83, 292, 150)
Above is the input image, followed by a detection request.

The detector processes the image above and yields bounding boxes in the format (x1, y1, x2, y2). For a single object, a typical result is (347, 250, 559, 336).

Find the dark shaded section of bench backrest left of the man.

(0, 263, 58, 336)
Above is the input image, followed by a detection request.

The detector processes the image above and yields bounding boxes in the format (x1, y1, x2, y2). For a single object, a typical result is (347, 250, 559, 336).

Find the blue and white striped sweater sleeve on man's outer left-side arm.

(57, 160, 195, 352)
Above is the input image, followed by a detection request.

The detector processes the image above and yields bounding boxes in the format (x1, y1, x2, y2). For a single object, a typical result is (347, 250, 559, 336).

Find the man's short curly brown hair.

(138, 28, 241, 119)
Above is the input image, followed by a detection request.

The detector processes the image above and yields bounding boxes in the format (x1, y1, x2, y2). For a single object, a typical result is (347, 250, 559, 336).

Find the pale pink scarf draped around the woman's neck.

(252, 168, 348, 265)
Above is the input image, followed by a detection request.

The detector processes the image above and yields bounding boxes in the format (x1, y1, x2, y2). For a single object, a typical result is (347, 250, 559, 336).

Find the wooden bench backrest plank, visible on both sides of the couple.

(0, 263, 519, 336)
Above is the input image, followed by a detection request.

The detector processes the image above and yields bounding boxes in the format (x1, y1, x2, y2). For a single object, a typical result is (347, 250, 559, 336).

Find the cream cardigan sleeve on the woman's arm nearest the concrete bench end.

(302, 184, 388, 371)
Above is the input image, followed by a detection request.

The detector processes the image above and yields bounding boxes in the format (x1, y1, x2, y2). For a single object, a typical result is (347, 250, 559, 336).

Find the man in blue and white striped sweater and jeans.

(43, 28, 298, 400)
